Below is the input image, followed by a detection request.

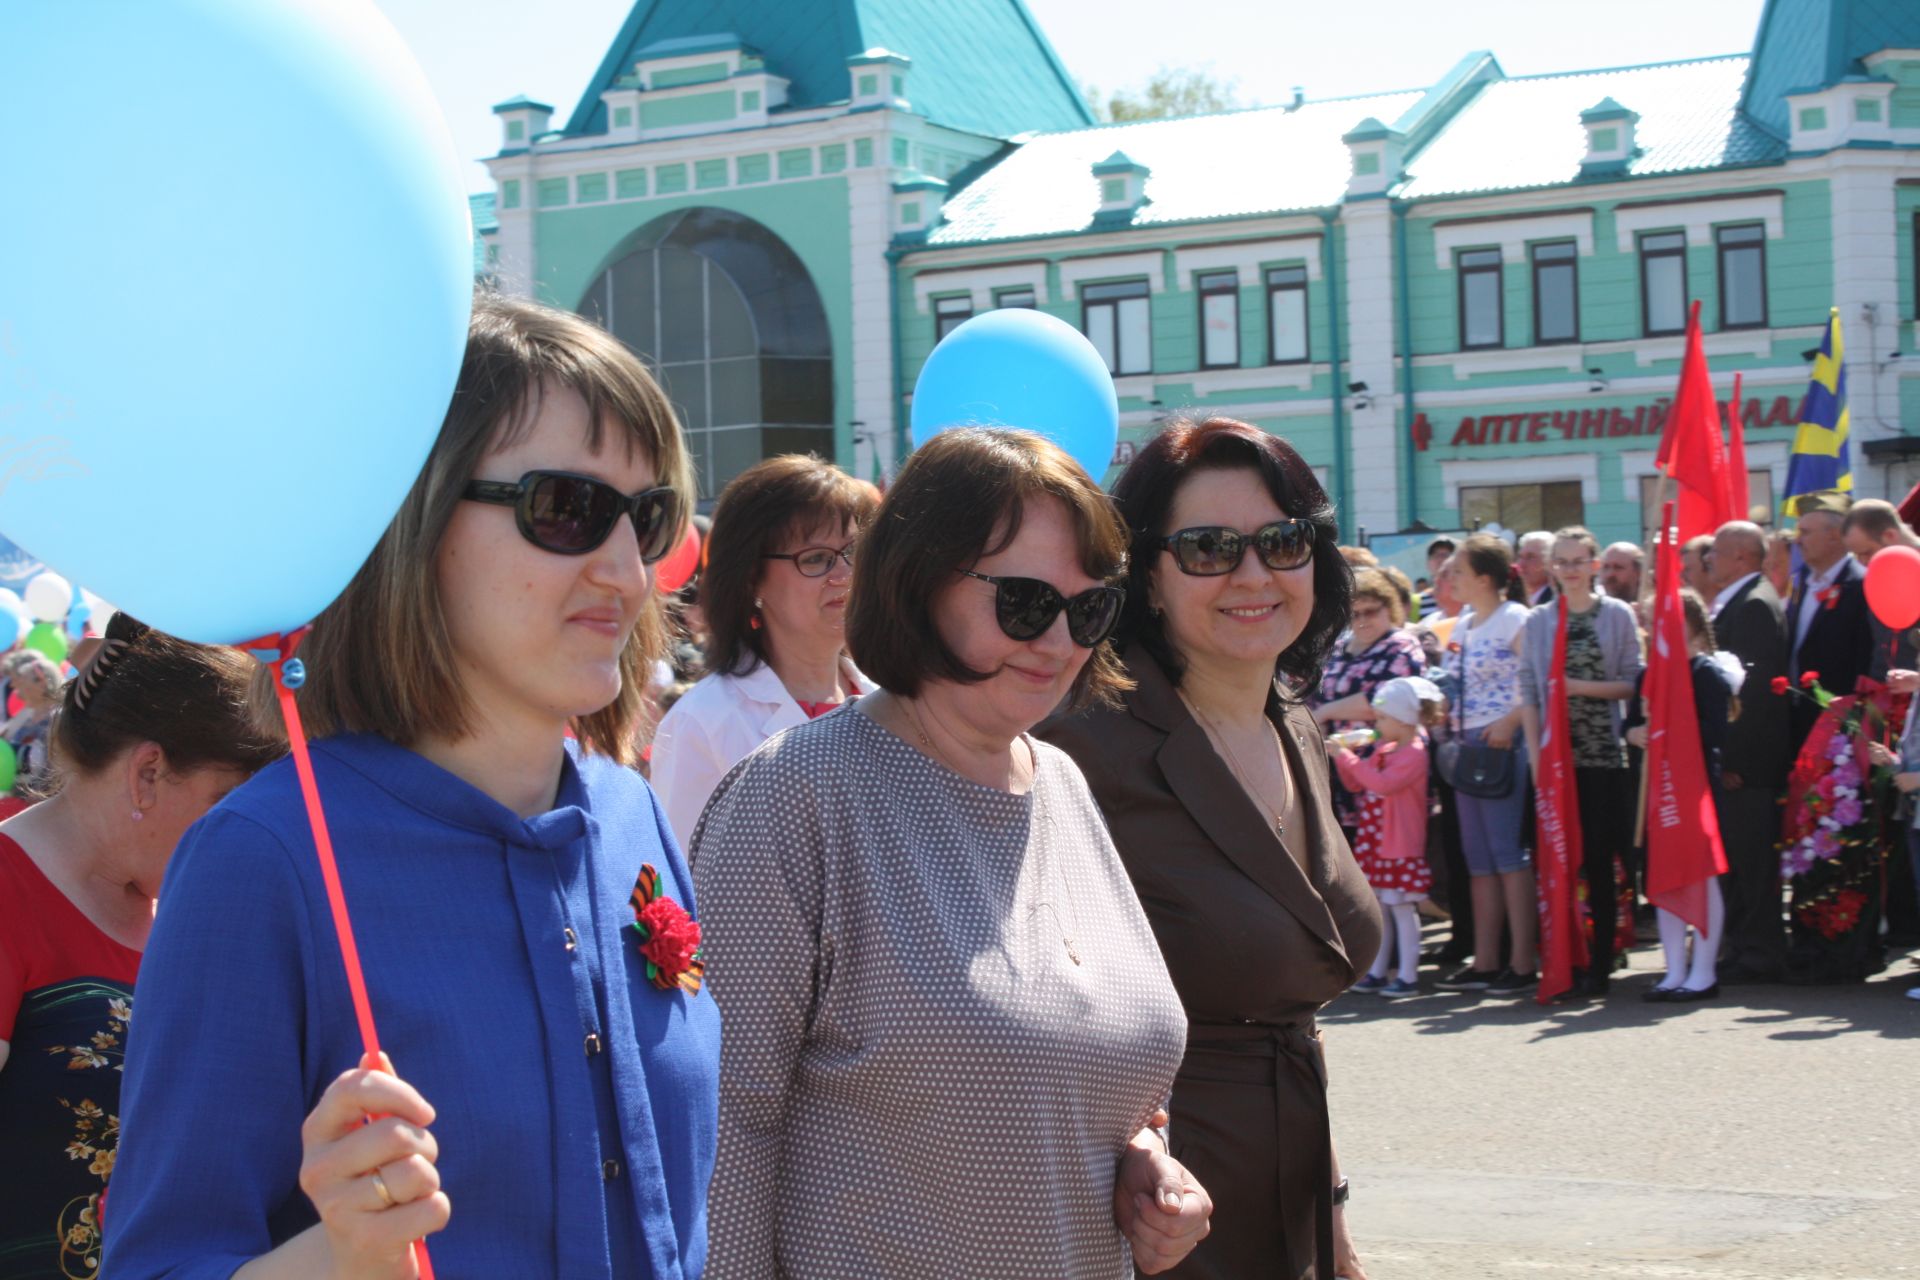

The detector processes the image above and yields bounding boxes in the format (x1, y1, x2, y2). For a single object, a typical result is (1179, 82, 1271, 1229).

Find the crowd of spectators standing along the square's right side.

(1313, 491, 1920, 1002)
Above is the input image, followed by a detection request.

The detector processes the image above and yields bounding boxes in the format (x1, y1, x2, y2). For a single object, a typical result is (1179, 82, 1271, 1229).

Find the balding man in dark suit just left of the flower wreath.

(1709, 520, 1793, 983)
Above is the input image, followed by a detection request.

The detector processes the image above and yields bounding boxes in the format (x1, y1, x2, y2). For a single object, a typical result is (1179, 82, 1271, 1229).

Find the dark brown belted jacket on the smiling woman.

(1037, 649, 1380, 1280)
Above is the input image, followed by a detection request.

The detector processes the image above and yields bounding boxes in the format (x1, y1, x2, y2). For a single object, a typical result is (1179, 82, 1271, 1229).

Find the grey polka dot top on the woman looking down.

(693, 708, 1187, 1280)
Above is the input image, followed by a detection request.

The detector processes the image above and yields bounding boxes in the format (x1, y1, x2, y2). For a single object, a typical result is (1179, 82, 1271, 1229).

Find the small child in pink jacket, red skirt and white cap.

(1332, 676, 1446, 1000)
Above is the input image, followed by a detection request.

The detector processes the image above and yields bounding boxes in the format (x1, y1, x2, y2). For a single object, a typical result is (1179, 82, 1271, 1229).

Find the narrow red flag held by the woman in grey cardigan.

(1534, 597, 1611, 1004)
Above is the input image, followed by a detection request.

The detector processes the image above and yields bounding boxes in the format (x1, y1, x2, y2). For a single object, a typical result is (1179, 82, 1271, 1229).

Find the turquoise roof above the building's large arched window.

(566, 0, 1092, 138)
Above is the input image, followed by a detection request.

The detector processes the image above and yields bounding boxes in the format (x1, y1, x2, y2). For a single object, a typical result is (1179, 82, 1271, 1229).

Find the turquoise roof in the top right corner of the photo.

(1740, 0, 1920, 138)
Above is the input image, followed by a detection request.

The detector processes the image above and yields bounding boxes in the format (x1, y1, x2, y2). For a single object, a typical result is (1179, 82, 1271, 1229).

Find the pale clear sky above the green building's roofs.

(376, 0, 1763, 192)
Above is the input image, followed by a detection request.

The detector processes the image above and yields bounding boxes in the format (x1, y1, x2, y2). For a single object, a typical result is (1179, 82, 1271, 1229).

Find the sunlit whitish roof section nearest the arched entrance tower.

(927, 90, 1436, 246)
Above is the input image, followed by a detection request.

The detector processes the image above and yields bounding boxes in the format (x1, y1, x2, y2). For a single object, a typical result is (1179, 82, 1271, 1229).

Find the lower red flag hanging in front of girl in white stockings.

(1645, 503, 1726, 932)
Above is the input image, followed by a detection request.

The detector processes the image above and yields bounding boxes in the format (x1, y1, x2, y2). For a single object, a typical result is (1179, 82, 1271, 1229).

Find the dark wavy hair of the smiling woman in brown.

(1114, 418, 1354, 697)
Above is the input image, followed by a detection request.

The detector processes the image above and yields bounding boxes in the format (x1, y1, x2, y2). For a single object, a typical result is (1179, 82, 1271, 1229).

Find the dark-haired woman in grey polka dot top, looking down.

(693, 430, 1212, 1280)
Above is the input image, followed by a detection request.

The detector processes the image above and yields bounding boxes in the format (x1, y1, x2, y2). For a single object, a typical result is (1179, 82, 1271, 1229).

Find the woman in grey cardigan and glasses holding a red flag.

(1521, 526, 1640, 1000)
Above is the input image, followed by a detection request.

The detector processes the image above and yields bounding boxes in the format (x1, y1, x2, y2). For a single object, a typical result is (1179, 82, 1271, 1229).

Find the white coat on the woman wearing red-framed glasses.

(651, 656, 874, 850)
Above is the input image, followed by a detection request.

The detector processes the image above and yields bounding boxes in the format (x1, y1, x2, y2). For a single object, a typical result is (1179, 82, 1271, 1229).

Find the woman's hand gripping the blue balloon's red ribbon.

(300, 1055, 453, 1280)
